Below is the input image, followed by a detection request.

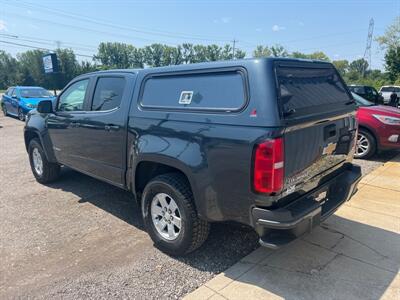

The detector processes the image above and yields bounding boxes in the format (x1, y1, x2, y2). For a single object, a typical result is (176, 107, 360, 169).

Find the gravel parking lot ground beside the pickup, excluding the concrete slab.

(0, 116, 394, 299)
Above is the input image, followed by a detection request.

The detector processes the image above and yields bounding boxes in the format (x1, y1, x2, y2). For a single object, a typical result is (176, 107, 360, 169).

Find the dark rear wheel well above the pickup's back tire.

(134, 161, 190, 195)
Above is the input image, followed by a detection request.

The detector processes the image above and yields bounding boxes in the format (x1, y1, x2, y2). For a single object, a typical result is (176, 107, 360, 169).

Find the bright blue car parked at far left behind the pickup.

(1, 86, 55, 121)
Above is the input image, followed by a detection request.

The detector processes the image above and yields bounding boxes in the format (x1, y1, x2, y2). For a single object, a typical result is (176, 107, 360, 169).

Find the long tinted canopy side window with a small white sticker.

(141, 71, 246, 111)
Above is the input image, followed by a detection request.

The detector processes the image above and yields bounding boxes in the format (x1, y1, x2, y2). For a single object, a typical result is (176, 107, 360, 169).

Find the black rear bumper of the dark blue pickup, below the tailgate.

(251, 165, 361, 249)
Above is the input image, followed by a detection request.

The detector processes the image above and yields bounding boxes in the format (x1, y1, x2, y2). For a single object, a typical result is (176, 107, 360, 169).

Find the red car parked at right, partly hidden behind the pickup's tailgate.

(353, 93, 400, 158)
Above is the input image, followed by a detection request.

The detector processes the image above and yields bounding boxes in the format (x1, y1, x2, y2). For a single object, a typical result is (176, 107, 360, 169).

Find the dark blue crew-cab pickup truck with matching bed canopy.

(24, 58, 361, 255)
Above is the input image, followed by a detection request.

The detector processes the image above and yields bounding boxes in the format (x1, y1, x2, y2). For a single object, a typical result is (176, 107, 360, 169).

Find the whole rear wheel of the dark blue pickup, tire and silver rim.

(142, 173, 210, 255)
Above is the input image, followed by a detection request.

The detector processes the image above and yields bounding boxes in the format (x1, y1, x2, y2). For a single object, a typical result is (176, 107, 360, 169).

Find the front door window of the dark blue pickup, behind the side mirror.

(57, 79, 89, 111)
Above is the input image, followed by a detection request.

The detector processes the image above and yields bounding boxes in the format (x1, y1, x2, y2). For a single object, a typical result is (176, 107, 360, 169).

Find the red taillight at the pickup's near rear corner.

(253, 138, 284, 194)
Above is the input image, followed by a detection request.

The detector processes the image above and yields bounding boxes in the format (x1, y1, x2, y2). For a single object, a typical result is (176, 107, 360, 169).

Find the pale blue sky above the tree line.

(0, 0, 400, 69)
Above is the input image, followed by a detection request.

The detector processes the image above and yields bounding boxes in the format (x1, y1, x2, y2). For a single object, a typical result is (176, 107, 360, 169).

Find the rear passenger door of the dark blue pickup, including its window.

(65, 73, 134, 185)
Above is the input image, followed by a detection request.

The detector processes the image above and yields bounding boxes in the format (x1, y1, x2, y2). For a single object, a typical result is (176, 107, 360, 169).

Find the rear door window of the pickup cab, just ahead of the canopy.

(92, 77, 125, 111)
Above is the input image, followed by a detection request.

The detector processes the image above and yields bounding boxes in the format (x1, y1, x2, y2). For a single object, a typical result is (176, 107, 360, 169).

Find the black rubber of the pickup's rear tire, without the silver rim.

(142, 173, 210, 256)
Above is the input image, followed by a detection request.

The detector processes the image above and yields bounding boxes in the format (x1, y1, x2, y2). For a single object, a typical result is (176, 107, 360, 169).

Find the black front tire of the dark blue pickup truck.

(28, 138, 60, 183)
